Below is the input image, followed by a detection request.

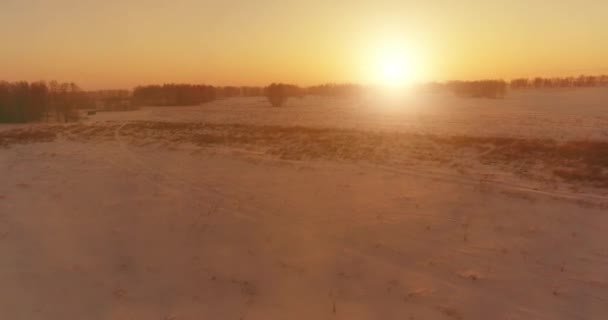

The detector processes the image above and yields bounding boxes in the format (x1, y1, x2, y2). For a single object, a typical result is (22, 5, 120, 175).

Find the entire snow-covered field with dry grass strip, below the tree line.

(0, 88, 608, 320)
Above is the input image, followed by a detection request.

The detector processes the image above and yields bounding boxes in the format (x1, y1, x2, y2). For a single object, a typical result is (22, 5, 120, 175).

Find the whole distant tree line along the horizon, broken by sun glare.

(0, 75, 608, 123)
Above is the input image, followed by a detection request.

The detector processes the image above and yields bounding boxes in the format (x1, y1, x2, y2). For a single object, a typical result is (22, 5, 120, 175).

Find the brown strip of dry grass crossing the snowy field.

(0, 121, 608, 188)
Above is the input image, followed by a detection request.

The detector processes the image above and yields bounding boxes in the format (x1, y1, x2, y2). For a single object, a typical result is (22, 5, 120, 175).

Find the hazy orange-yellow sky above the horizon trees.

(0, 0, 608, 89)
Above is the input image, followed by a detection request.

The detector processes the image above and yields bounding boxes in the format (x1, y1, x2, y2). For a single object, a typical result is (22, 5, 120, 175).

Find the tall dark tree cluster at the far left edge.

(0, 81, 86, 123)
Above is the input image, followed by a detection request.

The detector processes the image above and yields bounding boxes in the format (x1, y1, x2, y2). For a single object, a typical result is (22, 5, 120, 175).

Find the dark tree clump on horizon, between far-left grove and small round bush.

(133, 84, 217, 106)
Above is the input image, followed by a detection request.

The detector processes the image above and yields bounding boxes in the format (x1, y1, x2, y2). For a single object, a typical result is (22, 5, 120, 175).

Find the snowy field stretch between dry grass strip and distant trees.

(88, 87, 608, 140)
